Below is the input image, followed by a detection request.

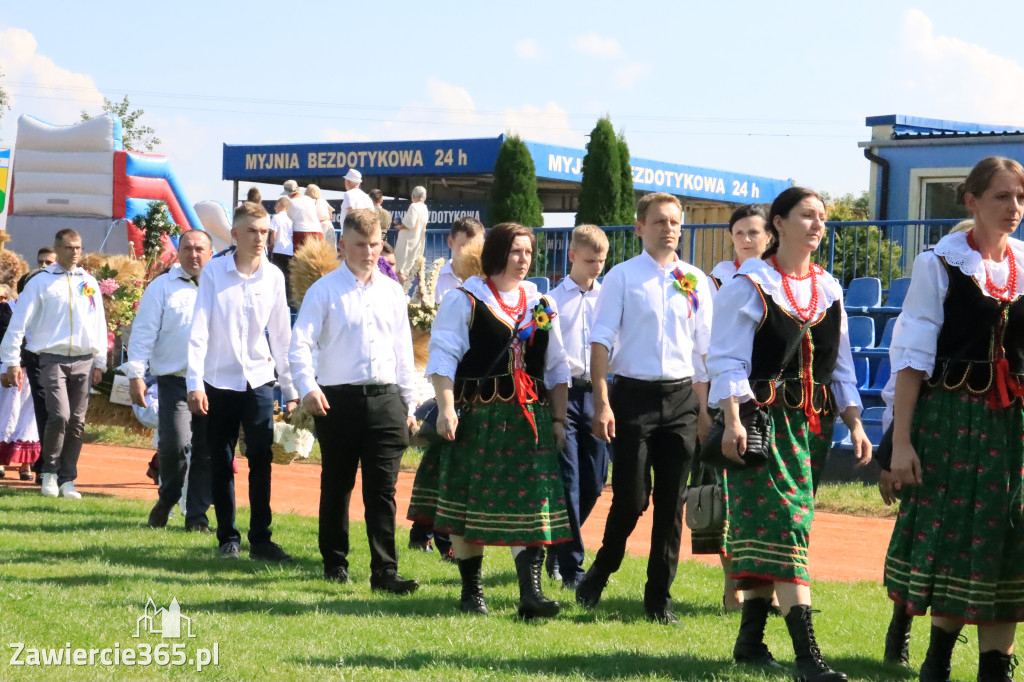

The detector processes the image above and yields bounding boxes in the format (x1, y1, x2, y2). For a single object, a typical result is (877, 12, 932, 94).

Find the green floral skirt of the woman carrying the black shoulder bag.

(723, 406, 833, 588)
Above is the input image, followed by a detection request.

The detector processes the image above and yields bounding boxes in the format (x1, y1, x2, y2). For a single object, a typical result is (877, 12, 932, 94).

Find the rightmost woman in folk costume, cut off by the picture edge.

(885, 157, 1024, 682)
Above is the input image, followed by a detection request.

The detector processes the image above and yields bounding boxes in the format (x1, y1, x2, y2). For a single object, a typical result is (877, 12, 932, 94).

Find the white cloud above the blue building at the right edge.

(893, 9, 1024, 125)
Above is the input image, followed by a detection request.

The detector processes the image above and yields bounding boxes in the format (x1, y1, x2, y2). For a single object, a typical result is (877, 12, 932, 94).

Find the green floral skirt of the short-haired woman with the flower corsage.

(408, 401, 572, 546)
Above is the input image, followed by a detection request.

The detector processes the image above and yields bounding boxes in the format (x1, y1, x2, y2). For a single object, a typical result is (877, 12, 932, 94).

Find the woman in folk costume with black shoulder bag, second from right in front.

(708, 187, 871, 682)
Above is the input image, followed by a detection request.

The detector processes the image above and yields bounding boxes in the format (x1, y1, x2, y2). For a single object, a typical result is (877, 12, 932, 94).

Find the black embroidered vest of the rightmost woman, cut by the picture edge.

(927, 256, 1024, 394)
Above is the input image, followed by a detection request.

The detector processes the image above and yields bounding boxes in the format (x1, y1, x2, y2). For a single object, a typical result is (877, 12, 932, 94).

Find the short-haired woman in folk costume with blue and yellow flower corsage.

(409, 223, 571, 619)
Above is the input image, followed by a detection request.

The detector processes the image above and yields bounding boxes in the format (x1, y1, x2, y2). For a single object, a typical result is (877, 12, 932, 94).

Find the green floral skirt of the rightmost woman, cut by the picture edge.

(885, 390, 1024, 624)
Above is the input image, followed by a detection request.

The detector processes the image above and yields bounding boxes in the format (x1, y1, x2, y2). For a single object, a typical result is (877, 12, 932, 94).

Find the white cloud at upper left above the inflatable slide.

(0, 29, 103, 142)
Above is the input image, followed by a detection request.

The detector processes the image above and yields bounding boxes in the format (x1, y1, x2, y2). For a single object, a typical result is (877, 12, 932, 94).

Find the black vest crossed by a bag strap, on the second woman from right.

(750, 280, 843, 413)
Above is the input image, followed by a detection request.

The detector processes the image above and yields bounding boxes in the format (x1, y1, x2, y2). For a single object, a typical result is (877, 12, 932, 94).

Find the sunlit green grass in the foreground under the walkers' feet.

(0, 487, 977, 680)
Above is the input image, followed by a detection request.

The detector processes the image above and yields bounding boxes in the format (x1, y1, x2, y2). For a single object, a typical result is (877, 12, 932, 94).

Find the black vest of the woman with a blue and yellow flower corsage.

(455, 287, 549, 404)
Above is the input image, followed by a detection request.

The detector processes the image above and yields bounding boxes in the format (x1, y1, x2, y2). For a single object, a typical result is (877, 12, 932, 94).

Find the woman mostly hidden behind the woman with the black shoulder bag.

(690, 204, 771, 611)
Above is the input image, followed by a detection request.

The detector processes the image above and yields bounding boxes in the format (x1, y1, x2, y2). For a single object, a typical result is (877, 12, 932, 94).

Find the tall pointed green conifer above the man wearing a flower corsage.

(575, 117, 632, 225)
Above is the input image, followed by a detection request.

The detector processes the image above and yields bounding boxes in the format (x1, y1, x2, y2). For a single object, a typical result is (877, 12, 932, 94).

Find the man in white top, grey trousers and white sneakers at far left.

(0, 229, 106, 499)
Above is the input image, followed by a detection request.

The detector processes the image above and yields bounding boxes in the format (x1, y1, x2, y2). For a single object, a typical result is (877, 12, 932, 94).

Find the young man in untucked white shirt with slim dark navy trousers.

(185, 202, 298, 561)
